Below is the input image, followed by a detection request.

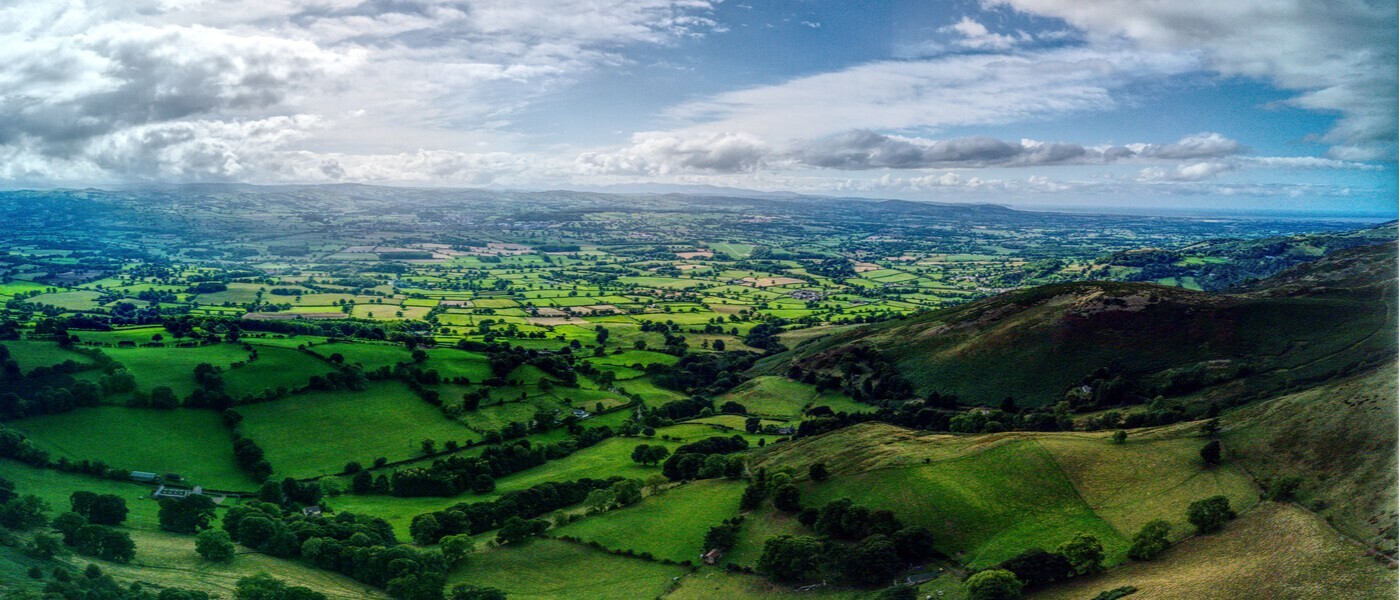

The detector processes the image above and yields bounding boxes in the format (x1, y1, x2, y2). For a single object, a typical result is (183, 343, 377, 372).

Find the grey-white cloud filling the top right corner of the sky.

(994, 0, 1397, 159)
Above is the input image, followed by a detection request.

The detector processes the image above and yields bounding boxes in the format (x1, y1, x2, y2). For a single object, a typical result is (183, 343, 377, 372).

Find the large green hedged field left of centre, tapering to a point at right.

(238, 383, 476, 477)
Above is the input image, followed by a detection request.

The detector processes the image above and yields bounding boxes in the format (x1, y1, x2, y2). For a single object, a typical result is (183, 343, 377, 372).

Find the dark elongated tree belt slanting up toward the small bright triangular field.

(409, 477, 622, 544)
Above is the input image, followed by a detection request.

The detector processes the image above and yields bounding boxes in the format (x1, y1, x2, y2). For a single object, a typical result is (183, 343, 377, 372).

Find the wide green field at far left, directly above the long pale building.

(10, 406, 256, 490)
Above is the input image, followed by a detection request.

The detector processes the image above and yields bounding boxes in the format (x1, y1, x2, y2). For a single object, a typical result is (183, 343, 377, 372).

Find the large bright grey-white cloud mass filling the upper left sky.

(0, 0, 715, 183)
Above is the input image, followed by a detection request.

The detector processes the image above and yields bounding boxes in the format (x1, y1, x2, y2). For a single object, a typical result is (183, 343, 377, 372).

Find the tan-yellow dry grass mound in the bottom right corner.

(1032, 502, 1396, 600)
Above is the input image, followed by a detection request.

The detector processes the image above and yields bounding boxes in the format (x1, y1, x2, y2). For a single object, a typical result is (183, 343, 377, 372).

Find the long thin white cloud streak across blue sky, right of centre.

(666, 48, 1197, 140)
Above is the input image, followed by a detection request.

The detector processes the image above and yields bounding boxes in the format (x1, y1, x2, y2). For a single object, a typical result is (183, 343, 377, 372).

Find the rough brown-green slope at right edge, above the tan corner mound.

(1224, 364, 1397, 555)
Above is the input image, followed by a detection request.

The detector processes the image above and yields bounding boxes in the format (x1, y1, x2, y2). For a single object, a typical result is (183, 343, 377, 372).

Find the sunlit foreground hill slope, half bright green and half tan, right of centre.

(756, 424, 1257, 566)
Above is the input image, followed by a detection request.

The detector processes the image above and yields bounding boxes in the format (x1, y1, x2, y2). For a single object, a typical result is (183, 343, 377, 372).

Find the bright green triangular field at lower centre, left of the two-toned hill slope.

(552, 480, 745, 564)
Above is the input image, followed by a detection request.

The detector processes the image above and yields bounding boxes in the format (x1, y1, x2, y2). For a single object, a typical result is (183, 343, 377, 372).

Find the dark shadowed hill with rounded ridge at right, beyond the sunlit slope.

(755, 245, 1396, 406)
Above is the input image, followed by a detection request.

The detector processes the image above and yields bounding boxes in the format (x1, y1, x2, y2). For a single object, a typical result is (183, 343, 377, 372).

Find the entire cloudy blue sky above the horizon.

(0, 0, 1400, 217)
